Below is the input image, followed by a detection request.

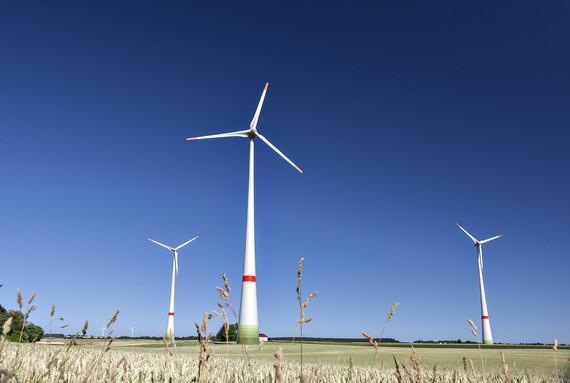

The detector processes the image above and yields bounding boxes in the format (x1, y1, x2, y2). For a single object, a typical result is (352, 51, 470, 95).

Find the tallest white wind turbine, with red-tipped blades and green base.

(186, 83, 303, 344)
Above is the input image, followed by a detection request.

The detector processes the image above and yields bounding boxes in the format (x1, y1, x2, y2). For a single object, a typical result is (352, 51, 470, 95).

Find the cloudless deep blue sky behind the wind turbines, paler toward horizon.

(0, 1, 570, 342)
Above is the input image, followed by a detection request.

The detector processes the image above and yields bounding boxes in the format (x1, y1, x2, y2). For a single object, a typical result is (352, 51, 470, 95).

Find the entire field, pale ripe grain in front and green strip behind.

(0, 340, 570, 382)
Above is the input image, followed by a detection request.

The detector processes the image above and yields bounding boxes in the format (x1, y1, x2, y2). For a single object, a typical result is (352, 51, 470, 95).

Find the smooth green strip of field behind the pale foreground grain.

(104, 340, 570, 373)
